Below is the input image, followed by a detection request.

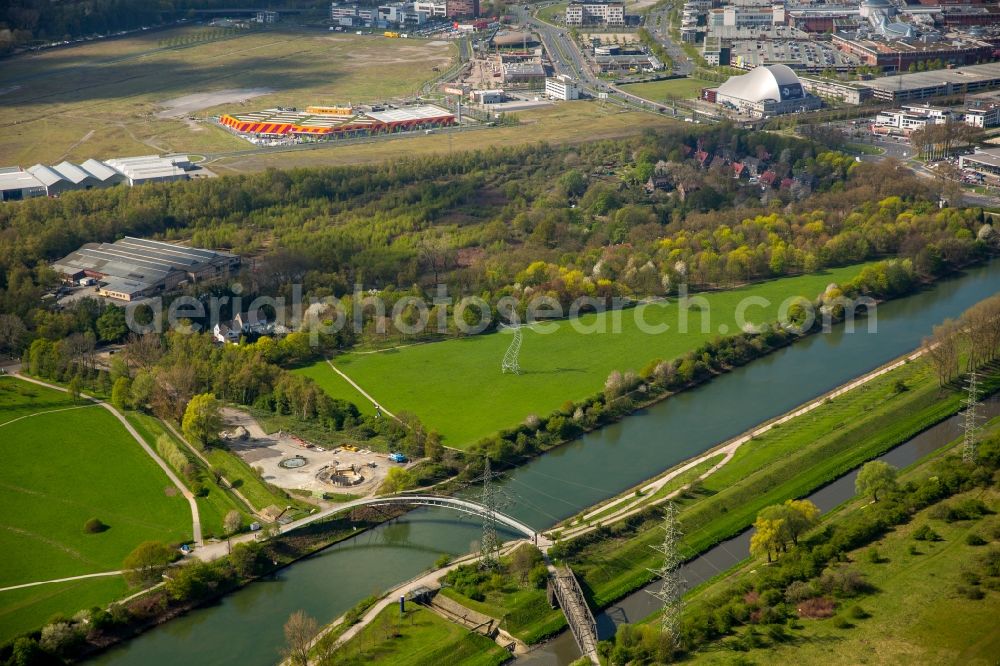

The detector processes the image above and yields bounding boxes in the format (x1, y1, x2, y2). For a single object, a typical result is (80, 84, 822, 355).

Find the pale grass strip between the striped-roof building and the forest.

(208, 101, 677, 174)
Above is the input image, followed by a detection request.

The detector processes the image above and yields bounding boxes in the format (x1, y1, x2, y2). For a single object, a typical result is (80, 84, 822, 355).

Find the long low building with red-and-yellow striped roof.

(219, 104, 455, 139)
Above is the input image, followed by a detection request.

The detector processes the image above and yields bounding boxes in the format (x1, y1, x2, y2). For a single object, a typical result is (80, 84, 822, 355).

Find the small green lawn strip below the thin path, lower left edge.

(0, 576, 128, 644)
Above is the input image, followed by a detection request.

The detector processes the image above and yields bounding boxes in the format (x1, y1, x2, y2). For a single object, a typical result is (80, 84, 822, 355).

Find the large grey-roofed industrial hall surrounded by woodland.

(52, 236, 240, 301)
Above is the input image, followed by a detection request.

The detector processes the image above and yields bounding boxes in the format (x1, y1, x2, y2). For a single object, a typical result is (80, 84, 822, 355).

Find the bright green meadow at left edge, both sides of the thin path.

(0, 377, 191, 641)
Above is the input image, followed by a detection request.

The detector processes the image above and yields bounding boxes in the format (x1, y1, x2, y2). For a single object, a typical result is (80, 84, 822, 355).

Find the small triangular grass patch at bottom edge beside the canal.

(331, 604, 511, 666)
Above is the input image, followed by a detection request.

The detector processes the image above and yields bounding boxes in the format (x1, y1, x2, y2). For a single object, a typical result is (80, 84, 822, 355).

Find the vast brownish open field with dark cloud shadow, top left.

(0, 26, 456, 165)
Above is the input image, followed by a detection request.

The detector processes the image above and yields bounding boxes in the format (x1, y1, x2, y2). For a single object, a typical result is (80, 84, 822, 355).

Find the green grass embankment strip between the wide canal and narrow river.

(572, 360, 988, 605)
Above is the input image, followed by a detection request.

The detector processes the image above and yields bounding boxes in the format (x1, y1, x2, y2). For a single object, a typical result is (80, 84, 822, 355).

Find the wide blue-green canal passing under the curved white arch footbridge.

(91, 261, 1000, 666)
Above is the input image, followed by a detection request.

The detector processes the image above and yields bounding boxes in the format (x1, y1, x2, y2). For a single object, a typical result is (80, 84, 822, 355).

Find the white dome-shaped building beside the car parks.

(715, 65, 822, 118)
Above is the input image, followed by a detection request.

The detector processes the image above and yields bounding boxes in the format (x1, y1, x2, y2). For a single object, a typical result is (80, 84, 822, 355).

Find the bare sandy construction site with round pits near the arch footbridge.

(222, 407, 396, 496)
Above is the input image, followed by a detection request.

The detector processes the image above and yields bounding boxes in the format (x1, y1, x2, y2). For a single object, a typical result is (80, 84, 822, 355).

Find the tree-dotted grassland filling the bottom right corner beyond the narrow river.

(668, 420, 1000, 664)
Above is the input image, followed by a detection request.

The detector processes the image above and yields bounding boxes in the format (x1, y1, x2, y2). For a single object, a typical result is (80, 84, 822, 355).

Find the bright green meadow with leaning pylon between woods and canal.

(299, 266, 861, 448)
